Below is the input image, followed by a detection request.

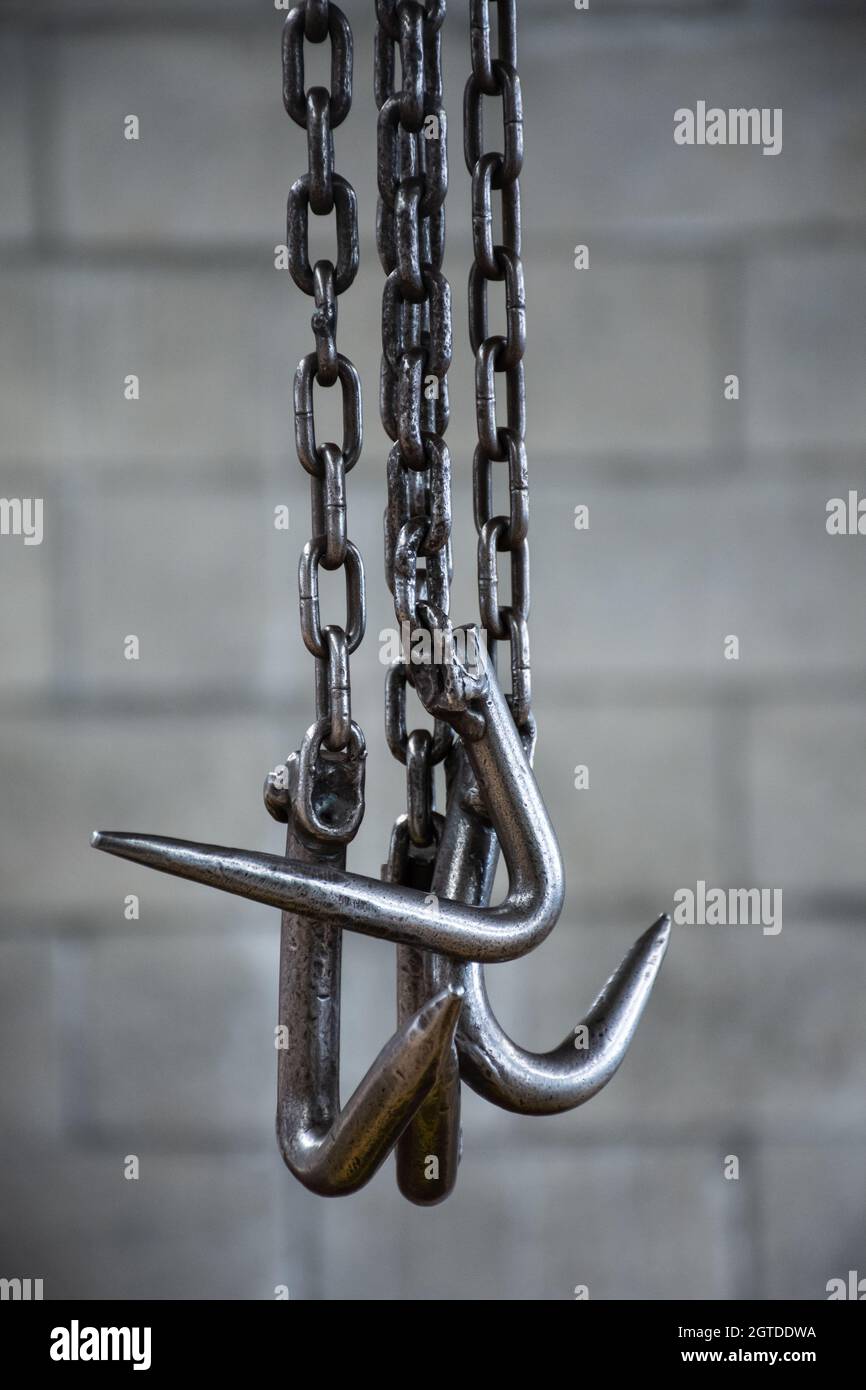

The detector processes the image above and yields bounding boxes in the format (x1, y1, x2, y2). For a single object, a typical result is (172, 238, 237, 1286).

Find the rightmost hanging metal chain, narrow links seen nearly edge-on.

(463, 0, 531, 731)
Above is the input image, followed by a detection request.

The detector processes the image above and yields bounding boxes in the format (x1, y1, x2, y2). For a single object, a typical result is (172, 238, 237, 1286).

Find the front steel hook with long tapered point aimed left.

(92, 647, 563, 962)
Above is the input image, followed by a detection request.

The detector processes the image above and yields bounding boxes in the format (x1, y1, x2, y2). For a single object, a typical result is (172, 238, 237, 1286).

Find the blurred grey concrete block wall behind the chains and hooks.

(0, 0, 866, 1300)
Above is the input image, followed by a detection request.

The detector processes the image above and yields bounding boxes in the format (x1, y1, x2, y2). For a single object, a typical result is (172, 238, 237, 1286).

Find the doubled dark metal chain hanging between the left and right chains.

(375, 0, 453, 856)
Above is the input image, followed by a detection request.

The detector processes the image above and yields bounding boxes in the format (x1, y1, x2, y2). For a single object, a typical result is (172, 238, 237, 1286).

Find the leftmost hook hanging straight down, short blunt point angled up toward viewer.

(226, 724, 463, 1197)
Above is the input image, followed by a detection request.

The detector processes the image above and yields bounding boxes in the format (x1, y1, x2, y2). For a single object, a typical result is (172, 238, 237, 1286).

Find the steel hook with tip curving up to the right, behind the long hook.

(436, 745, 670, 1115)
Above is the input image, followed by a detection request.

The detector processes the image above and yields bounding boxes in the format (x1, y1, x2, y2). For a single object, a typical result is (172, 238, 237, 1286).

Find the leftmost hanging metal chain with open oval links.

(282, 0, 367, 841)
